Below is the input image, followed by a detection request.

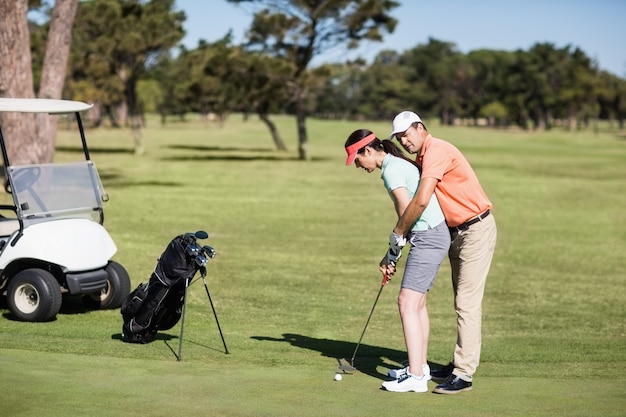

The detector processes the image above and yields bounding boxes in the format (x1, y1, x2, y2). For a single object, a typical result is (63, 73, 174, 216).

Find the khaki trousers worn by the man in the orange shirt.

(448, 215, 497, 381)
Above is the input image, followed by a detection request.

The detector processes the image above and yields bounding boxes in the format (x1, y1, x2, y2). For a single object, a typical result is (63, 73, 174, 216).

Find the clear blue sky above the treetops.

(175, 0, 626, 78)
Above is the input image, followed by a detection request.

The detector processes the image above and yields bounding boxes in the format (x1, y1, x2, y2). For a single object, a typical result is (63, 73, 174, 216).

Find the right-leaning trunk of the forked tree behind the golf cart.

(35, 0, 78, 162)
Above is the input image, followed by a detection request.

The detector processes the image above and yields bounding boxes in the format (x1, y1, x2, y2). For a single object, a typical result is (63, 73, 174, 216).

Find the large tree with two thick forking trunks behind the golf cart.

(0, 0, 78, 164)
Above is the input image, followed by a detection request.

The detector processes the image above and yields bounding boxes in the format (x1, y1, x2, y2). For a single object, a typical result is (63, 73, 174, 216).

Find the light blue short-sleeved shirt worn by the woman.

(380, 154, 445, 232)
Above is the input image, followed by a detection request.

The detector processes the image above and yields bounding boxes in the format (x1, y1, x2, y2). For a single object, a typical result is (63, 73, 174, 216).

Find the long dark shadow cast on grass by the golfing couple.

(251, 333, 428, 380)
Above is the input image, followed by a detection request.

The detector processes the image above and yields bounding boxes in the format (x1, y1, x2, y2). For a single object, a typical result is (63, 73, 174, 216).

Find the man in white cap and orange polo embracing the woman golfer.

(381, 111, 497, 394)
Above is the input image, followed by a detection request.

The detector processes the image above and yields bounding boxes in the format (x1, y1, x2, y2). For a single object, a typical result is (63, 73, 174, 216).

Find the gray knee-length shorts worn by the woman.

(402, 222, 450, 294)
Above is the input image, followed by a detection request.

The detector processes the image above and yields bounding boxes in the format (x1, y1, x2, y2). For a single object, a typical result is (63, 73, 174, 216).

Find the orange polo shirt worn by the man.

(416, 134, 492, 227)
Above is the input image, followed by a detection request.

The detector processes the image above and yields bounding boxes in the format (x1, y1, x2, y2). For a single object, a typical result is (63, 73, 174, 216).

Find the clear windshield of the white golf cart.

(7, 161, 107, 227)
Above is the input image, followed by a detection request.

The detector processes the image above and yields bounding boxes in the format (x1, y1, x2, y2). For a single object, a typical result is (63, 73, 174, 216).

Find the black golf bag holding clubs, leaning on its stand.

(121, 232, 215, 343)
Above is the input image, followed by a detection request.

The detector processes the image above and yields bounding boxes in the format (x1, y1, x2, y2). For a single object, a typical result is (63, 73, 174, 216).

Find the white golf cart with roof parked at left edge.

(0, 98, 130, 322)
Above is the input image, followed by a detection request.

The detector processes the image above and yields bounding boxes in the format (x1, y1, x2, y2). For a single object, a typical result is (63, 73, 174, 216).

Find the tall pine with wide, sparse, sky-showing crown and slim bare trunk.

(228, 0, 399, 160)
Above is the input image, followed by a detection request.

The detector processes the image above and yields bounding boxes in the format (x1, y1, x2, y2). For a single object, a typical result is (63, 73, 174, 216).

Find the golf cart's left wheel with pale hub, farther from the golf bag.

(7, 268, 62, 322)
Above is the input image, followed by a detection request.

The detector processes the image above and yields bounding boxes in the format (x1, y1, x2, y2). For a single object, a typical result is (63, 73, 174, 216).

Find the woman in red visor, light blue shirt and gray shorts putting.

(345, 129, 450, 392)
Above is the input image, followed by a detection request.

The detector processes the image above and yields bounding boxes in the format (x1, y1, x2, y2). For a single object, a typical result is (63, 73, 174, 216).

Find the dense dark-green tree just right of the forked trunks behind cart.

(73, 0, 185, 153)
